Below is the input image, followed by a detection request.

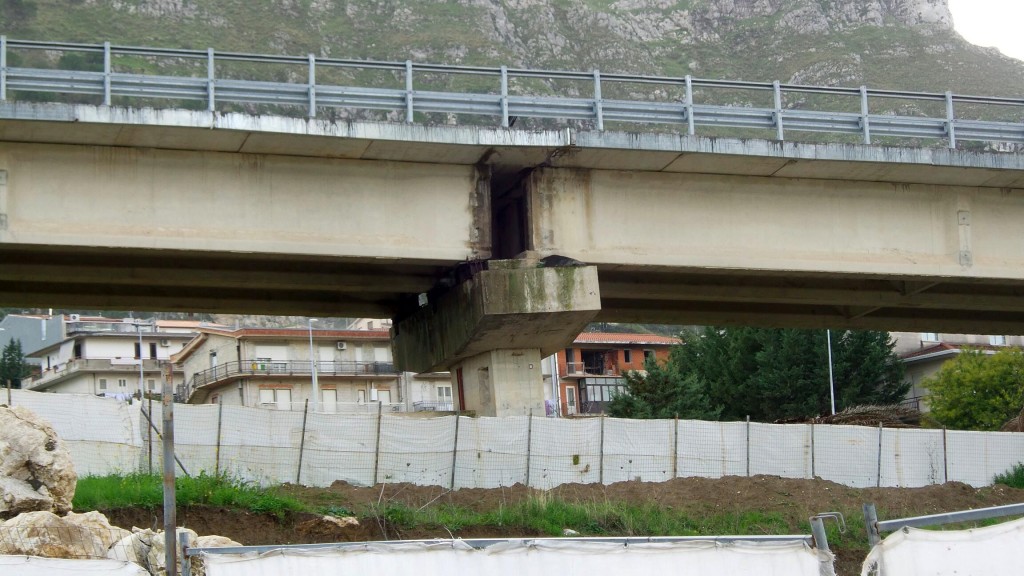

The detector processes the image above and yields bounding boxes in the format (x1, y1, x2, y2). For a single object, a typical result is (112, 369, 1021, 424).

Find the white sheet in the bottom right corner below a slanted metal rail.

(861, 512, 1024, 576)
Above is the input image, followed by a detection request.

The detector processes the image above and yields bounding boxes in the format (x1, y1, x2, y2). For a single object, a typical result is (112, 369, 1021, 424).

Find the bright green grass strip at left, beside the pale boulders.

(72, 474, 309, 518)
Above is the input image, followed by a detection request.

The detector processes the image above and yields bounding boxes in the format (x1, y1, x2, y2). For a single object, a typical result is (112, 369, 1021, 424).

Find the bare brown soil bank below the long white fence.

(102, 476, 1024, 576)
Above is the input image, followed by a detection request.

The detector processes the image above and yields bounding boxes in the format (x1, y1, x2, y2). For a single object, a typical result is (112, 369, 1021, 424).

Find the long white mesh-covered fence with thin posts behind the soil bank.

(12, 390, 1024, 489)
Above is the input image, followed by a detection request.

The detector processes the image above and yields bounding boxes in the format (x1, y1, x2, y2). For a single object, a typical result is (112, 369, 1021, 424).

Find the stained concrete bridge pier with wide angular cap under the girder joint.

(391, 256, 601, 416)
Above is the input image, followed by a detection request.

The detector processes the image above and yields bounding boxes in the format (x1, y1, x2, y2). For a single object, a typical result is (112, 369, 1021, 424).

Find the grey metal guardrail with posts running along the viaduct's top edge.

(0, 36, 1024, 148)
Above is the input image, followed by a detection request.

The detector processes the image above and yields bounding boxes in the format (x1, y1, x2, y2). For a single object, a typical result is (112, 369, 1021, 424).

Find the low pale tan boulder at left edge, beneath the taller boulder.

(0, 511, 106, 559)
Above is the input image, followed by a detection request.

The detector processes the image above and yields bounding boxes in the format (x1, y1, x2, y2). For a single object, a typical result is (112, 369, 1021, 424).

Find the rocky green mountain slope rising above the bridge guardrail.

(0, 0, 1024, 95)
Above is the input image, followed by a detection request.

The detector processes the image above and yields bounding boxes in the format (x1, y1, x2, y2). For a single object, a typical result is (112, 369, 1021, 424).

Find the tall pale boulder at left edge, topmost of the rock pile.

(0, 406, 78, 518)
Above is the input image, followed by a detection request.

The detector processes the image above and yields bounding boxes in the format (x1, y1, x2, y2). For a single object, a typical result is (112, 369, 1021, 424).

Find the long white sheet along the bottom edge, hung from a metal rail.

(204, 540, 830, 576)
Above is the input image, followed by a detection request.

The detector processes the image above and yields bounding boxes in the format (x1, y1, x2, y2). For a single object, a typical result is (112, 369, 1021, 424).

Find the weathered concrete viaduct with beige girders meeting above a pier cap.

(0, 102, 1024, 414)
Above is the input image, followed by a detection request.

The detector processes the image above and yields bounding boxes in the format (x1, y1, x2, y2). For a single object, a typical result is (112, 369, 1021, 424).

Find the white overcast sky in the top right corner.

(949, 0, 1024, 60)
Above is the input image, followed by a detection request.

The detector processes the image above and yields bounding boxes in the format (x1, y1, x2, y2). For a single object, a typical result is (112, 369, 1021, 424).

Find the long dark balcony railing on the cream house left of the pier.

(182, 360, 398, 399)
